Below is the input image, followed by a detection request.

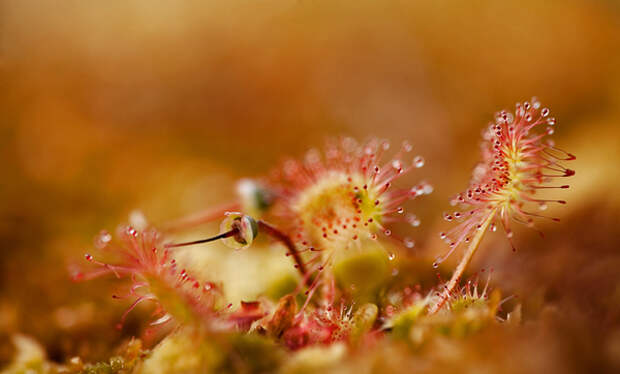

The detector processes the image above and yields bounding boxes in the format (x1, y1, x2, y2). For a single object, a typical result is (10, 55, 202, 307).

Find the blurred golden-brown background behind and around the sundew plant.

(0, 0, 620, 368)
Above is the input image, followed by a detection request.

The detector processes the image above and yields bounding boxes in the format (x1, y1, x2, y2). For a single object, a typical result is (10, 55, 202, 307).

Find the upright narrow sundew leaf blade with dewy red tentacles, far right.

(434, 98, 575, 266)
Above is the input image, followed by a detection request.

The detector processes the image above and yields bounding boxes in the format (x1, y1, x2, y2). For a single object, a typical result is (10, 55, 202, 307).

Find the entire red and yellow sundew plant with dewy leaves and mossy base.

(15, 98, 575, 373)
